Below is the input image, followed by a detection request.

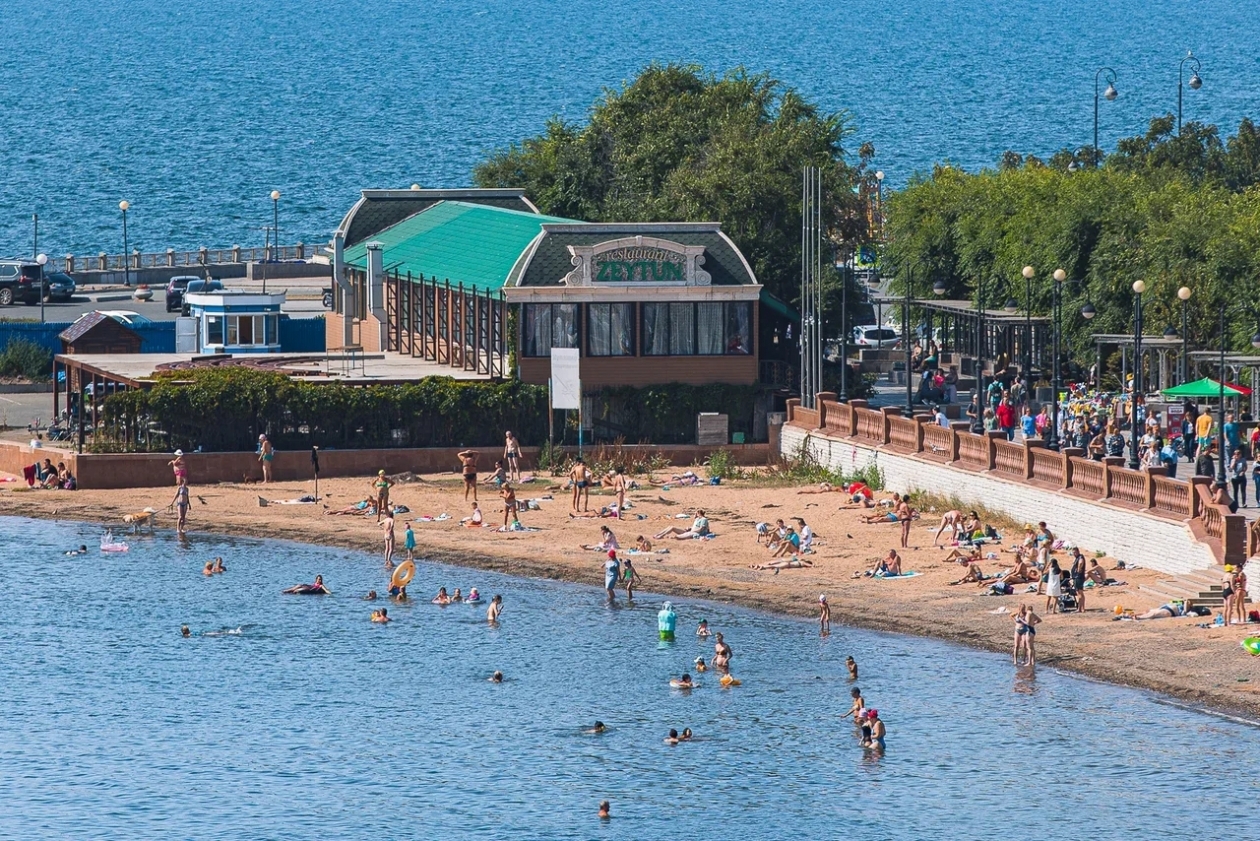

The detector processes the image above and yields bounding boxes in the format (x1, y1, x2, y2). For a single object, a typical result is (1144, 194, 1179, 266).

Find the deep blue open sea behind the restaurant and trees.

(0, 0, 1260, 255)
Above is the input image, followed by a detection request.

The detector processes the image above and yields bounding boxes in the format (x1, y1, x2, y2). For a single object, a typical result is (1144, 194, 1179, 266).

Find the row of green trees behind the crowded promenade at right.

(885, 117, 1260, 368)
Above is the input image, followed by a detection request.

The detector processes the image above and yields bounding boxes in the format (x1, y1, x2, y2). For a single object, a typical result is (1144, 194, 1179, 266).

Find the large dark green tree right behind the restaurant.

(473, 64, 873, 301)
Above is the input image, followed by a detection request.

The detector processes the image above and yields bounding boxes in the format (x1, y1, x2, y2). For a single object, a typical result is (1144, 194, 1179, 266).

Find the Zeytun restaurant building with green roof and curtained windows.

(326, 189, 794, 391)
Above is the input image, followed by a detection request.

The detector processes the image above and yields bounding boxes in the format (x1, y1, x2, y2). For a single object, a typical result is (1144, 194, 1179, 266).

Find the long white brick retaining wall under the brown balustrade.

(780, 425, 1216, 574)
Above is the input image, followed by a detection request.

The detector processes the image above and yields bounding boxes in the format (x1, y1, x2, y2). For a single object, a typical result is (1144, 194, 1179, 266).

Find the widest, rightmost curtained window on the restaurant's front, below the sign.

(643, 303, 752, 357)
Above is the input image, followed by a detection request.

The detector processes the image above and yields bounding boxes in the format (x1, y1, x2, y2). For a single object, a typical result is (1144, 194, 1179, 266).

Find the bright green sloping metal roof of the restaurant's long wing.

(345, 202, 572, 290)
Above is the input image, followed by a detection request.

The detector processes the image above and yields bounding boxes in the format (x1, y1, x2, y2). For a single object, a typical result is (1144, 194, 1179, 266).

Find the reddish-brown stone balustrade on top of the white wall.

(788, 392, 1244, 562)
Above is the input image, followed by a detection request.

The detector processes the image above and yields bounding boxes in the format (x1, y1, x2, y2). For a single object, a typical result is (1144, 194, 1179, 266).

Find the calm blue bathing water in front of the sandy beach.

(0, 518, 1260, 840)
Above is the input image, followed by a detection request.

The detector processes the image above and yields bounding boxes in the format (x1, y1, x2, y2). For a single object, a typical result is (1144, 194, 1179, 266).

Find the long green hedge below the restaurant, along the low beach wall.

(95, 368, 759, 451)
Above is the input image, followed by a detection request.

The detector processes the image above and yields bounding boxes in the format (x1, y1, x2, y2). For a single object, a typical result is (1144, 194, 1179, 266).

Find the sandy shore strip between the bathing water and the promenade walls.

(0, 474, 1260, 724)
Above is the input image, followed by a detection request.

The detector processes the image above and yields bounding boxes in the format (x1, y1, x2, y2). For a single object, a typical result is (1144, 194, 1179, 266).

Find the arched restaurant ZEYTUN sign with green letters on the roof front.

(563, 236, 712, 286)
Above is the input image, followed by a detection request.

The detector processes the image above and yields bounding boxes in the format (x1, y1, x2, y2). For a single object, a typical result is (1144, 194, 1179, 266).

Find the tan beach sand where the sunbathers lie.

(0, 466, 1260, 716)
